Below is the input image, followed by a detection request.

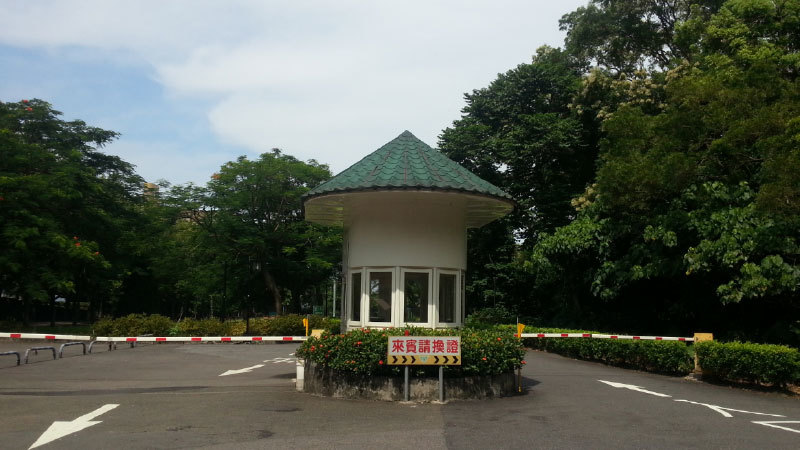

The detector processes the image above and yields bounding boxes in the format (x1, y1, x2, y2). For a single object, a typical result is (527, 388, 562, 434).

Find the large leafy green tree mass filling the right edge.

(528, 0, 800, 342)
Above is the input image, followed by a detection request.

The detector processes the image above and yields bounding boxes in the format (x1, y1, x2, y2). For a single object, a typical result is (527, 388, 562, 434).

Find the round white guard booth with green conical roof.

(303, 131, 514, 328)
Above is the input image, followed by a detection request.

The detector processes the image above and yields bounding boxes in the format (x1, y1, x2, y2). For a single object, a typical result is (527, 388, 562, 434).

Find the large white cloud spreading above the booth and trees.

(0, 0, 586, 178)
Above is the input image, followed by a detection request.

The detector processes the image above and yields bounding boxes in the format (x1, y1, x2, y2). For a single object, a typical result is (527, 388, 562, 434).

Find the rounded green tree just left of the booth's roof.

(177, 149, 341, 320)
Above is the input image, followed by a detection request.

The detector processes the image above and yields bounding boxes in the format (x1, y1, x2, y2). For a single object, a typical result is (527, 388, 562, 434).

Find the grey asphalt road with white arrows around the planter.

(0, 341, 800, 449)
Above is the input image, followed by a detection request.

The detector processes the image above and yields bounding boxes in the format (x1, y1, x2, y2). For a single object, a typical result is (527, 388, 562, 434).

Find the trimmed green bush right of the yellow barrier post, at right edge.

(694, 341, 800, 386)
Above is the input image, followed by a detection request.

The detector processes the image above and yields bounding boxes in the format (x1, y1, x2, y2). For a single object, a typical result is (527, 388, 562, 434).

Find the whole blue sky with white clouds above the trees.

(0, 0, 588, 184)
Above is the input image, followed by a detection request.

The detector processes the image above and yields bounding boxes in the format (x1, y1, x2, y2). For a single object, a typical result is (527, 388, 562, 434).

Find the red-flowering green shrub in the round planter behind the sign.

(296, 327, 525, 377)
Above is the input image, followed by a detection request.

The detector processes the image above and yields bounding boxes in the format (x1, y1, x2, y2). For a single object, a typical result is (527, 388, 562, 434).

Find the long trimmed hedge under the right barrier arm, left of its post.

(502, 326, 694, 375)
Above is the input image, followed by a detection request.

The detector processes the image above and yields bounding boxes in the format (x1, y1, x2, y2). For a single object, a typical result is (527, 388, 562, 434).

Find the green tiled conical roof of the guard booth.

(304, 131, 513, 202)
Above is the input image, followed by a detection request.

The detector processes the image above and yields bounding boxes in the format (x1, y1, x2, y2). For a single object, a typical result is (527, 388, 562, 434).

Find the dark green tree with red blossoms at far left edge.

(0, 99, 142, 322)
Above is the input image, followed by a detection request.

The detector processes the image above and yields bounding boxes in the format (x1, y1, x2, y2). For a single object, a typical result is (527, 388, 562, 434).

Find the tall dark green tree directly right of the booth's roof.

(439, 47, 597, 312)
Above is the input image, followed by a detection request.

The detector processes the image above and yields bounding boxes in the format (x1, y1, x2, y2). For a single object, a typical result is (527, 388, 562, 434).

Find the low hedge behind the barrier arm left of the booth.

(92, 314, 340, 336)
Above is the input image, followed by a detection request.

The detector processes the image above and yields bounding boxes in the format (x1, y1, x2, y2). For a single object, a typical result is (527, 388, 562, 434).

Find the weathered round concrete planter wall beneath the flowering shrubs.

(298, 362, 517, 402)
